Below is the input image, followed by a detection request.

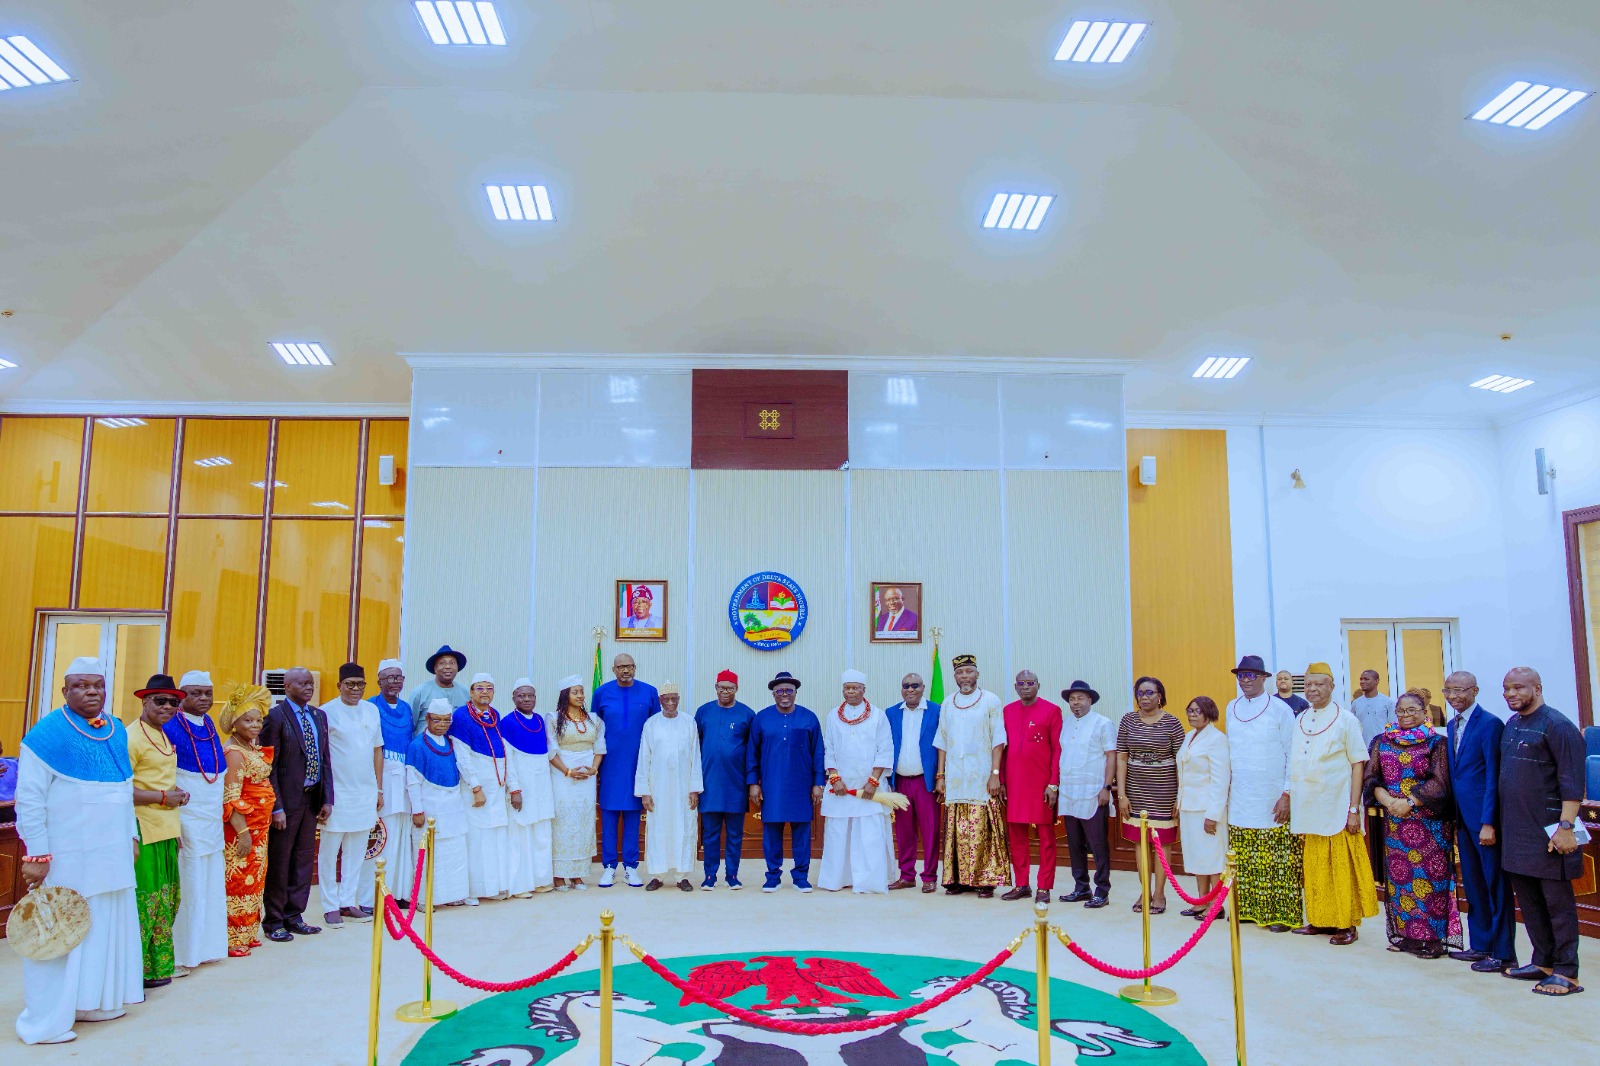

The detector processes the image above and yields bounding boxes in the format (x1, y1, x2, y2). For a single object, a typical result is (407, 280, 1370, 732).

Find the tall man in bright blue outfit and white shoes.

(589, 653, 661, 888)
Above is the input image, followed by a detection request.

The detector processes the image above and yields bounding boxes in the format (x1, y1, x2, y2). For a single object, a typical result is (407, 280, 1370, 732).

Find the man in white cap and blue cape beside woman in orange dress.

(163, 671, 227, 970)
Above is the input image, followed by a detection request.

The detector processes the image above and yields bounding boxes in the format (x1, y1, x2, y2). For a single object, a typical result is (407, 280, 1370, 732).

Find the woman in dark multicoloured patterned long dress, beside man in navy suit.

(1365, 691, 1461, 959)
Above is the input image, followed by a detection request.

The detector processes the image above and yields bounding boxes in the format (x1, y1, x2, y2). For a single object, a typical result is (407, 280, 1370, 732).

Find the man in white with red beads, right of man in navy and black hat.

(816, 671, 894, 893)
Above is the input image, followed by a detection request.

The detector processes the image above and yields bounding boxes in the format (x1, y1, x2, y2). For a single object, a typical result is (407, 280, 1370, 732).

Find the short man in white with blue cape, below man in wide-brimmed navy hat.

(402, 696, 470, 906)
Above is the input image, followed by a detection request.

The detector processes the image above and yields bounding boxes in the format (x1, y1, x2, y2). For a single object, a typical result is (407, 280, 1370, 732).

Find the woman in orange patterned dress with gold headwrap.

(218, 685, 277, 959)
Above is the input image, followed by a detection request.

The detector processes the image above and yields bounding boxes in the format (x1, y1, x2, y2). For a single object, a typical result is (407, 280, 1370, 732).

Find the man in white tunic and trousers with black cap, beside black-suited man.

(317, 663, 384, 928)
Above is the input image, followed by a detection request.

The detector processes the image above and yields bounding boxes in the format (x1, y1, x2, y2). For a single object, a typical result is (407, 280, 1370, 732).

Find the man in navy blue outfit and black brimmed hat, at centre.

(746, 671, 827, 892)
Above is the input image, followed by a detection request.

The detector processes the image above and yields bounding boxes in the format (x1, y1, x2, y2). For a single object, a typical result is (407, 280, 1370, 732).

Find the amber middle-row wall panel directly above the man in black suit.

(261, 519, 355, 688)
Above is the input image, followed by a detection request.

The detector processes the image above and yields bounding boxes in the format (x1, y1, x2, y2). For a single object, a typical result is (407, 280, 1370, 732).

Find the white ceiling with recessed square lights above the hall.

(0, 0, 1600, 419)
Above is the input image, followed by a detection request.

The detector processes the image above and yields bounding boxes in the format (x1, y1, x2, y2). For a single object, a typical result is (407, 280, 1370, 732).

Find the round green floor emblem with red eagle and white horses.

(405, 951, 1205, 1066)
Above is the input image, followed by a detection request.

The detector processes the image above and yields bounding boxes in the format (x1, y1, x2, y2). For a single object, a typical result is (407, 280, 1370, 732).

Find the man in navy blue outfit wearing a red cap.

(694, 671, 755, 892)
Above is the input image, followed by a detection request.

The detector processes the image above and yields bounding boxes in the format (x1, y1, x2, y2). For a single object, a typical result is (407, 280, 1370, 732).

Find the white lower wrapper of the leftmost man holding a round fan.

(16, 888, 144, 1044)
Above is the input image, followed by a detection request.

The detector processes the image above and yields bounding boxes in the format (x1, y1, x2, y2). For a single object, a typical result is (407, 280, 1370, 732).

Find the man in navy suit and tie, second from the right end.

(1445, 671, 1517, 973)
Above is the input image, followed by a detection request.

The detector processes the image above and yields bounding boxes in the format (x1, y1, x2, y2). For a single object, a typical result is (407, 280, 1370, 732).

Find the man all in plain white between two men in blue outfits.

(634, 682, 706, 892)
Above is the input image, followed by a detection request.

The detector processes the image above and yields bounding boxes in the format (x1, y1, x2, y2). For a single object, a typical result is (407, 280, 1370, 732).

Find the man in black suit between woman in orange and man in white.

(261, 666, 333, 944)
